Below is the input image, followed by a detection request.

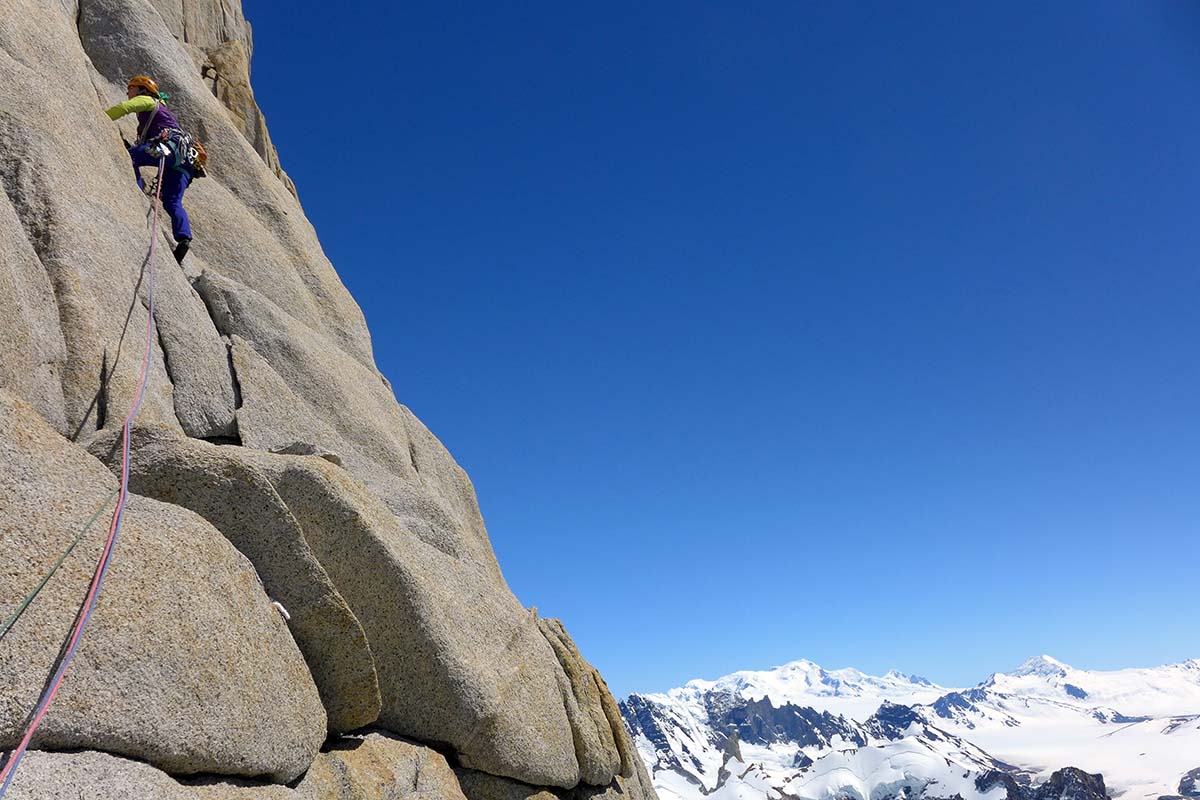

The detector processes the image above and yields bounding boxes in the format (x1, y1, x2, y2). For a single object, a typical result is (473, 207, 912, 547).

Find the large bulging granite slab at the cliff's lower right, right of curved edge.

(219, 431, 580, 787)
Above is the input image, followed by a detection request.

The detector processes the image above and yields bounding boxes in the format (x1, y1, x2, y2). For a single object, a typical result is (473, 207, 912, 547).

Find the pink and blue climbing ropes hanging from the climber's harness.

(0, 156, 166, 798)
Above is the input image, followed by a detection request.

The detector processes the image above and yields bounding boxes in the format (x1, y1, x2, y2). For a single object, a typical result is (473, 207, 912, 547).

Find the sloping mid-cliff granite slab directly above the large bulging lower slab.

(196, 273, 503, 583)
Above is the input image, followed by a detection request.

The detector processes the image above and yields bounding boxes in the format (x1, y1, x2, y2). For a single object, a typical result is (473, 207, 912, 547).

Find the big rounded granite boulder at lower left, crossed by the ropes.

(0, 391, 325, 781)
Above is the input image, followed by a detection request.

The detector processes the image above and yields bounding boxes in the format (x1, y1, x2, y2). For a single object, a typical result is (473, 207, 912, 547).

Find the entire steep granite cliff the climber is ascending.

(0, 0, 654, 800)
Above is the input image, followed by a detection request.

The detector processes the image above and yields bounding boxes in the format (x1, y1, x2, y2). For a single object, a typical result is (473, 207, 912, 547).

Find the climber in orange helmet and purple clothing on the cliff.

(106, 76, 203, 264)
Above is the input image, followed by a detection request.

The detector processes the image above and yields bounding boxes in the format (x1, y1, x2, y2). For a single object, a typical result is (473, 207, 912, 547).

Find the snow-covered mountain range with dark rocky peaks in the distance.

(620, 656, 1200, 800)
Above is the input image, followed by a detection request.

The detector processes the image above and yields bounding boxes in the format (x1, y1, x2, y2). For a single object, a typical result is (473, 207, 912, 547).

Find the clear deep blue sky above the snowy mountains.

(245, 0, 1200, 694)
